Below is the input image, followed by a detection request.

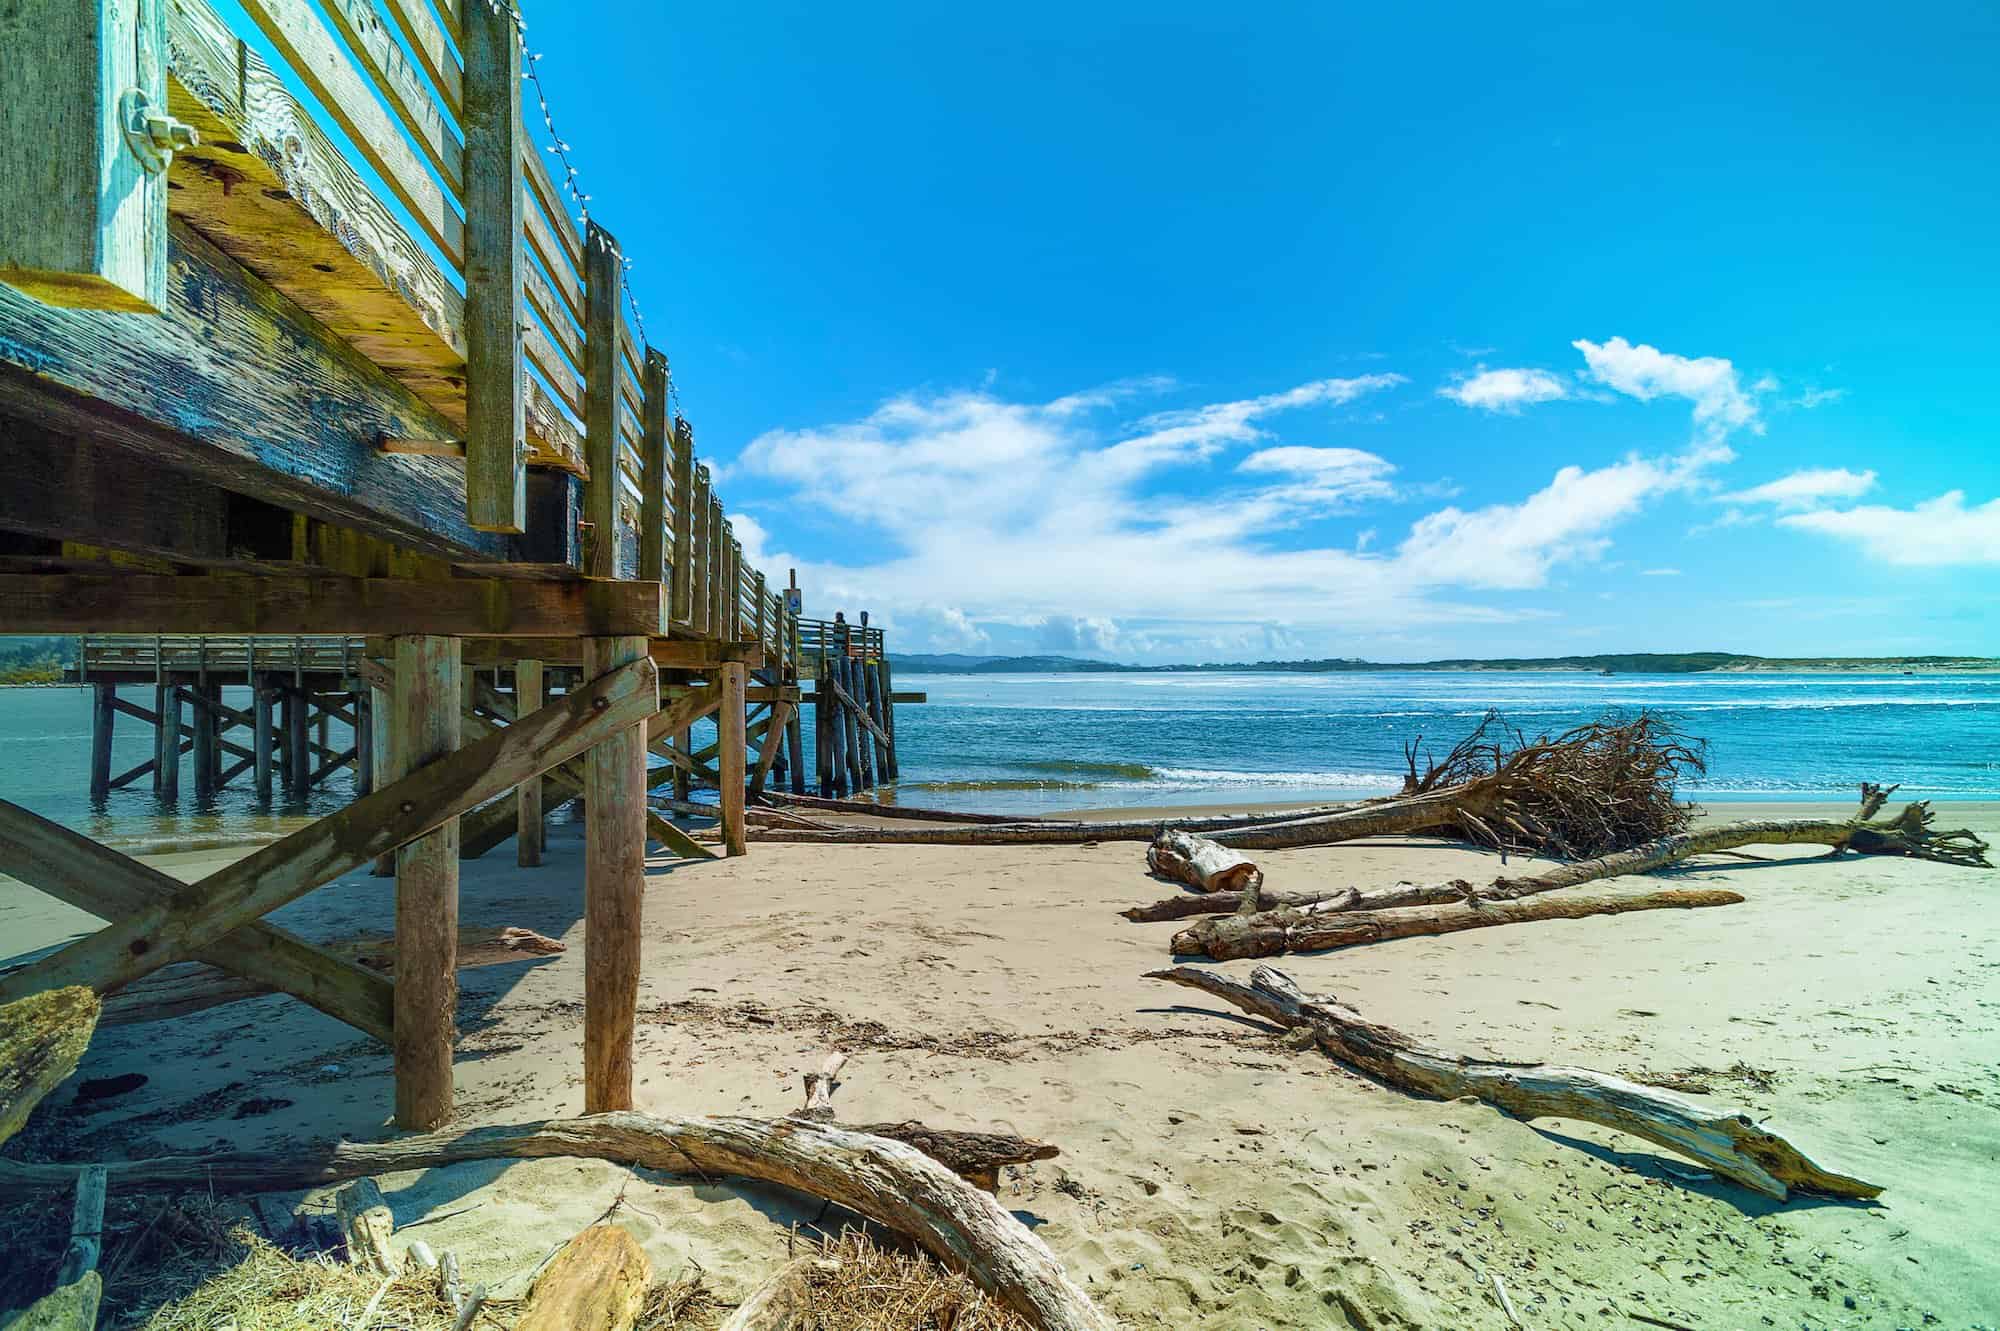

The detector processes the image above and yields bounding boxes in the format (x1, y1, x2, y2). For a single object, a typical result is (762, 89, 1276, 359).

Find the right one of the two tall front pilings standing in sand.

(584, 631, 646, 1113)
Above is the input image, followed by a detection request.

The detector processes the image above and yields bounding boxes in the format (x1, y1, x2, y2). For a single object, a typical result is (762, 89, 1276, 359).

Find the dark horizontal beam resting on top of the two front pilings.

(0, 574, 666, 638)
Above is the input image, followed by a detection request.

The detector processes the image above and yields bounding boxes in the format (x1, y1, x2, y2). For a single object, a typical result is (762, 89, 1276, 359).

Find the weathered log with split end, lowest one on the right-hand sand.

(1148, 965, 1882, 1201)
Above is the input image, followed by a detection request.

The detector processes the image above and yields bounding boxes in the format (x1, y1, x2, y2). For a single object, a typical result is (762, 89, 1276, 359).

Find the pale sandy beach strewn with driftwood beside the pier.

(0, 803, 2000, 1331)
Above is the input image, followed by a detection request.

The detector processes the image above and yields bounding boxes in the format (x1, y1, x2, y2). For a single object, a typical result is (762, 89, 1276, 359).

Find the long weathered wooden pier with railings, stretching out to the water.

(0, 0, 896, 1127)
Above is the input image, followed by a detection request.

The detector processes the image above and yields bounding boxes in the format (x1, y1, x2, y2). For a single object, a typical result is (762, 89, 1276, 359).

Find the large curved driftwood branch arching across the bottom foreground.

(0, 1113, 1112, 1331)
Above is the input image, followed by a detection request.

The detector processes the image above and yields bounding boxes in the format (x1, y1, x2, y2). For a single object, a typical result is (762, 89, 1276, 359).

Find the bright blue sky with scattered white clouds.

(528, 4, 2000, 662)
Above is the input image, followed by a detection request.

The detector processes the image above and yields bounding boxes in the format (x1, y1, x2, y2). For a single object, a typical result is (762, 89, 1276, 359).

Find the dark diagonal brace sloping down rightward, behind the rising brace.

(0, 801, 390, 1043)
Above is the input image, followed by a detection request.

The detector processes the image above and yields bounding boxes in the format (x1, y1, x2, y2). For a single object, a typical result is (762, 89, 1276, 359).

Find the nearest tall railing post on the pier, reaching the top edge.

(458, 4, 532, 532)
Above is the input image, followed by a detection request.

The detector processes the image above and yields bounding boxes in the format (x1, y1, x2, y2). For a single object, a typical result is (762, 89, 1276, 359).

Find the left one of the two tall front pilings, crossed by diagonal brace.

(396, 634, 460, 1131)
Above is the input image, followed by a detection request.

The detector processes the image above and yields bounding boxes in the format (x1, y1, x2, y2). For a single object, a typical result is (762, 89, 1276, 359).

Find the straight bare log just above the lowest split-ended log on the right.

(1172, 887, 1742, 961)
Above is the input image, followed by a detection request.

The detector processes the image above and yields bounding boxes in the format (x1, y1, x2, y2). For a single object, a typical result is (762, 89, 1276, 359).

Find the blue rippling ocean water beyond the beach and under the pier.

(0, 671, 2000, 839)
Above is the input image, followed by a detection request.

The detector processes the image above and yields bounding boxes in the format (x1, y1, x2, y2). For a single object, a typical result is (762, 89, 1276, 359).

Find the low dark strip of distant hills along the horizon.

(890, 652, 2000, 675)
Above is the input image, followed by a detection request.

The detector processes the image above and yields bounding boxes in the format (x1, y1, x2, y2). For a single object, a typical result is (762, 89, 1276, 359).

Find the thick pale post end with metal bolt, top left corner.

(0, 0, 174, 314)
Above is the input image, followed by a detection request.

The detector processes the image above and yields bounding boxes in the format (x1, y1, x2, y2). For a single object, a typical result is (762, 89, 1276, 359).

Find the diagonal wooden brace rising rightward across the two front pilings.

(0, 662, 660, 1003)
